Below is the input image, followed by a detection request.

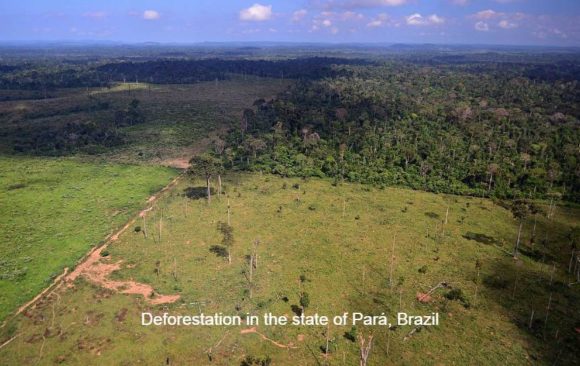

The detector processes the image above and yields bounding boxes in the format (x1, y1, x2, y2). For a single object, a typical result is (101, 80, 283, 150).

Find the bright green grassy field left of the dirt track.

(0, 157, 177, 319)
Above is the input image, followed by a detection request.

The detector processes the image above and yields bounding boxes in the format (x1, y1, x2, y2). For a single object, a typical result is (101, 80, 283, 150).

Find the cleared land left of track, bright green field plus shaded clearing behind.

(0, 78, 288, 320)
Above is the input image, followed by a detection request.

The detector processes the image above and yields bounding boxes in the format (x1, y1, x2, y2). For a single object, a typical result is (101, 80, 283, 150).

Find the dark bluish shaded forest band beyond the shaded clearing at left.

(0, 57, 369, 91)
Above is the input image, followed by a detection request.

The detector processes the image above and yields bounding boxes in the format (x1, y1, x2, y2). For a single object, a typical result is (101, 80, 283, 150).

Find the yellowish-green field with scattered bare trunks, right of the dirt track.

(0, 174, 580, 365)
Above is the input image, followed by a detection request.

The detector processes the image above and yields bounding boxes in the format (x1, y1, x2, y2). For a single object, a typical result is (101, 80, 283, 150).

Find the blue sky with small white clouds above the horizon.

(0, 0, 580, 46)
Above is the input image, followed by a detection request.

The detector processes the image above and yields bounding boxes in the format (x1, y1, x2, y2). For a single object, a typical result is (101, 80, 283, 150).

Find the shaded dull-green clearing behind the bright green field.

(0, 77, 290, 168)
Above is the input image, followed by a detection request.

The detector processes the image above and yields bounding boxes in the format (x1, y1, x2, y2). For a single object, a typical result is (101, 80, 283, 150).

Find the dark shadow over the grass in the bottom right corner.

(481, 257, 580, 365)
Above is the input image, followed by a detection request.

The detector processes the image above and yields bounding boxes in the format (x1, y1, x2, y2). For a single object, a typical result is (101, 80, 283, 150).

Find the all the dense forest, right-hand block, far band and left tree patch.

(0, 50, 580, 202)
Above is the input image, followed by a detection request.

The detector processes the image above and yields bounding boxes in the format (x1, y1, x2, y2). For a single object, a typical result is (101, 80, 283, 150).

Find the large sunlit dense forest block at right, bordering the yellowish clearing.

(223, 62, 580, 202)
